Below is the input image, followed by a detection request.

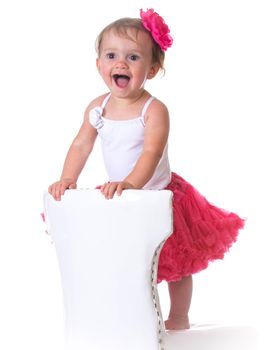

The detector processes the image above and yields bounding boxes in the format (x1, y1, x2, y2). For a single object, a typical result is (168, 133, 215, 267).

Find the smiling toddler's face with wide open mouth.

(96, 29, 159, 97)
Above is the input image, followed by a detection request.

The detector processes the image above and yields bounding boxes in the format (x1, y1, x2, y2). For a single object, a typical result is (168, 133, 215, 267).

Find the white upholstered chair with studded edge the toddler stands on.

(44, 190, 256, 350)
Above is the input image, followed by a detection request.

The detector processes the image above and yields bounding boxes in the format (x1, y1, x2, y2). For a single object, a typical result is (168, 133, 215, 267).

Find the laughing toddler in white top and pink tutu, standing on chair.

(49, 9, 244, 330)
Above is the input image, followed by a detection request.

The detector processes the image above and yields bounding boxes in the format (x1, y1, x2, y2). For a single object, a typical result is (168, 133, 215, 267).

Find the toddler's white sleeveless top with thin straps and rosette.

(89, 94, 171, 190)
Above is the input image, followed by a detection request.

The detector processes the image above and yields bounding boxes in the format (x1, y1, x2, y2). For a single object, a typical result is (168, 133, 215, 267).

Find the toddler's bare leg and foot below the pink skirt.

(165, 276, 193, 330)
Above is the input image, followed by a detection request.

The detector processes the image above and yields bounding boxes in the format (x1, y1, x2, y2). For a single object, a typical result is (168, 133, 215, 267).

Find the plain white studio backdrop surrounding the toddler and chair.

(0, 0, 280, 350)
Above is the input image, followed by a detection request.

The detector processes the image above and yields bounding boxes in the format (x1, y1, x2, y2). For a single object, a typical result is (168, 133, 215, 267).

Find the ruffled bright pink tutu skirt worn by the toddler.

(158, 173, 244, 282)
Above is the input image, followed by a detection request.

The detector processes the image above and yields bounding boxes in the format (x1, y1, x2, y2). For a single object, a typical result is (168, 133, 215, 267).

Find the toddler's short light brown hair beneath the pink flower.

(95, 17, 165, 70)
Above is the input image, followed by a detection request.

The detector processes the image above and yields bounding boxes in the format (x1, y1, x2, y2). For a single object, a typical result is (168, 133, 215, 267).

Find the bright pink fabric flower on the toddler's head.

(140, 9, 173, 51)
